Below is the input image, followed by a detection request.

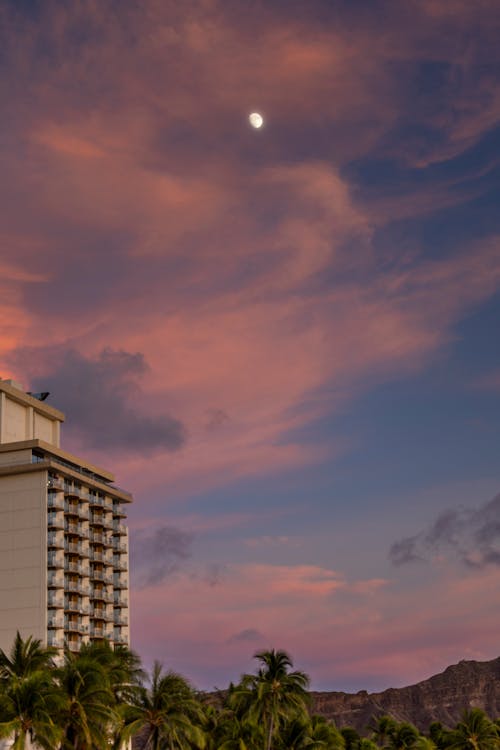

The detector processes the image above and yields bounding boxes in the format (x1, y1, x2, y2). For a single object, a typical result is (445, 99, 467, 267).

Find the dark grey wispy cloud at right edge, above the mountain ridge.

(389, 495, 500, 569)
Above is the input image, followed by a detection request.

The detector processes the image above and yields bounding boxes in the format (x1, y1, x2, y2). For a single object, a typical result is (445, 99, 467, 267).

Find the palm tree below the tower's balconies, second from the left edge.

(56, 650, 117, 750)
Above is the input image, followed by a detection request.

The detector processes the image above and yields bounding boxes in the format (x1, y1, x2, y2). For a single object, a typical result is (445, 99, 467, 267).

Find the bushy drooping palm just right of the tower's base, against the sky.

(121, 662, 206, 750)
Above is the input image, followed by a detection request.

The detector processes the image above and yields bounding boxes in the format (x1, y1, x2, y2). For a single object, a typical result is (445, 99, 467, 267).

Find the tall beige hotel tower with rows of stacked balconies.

(0, 379, 132, 650)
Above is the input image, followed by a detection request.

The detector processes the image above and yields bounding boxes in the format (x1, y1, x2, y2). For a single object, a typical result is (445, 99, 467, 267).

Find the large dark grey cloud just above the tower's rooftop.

(12, 347, 185, 455)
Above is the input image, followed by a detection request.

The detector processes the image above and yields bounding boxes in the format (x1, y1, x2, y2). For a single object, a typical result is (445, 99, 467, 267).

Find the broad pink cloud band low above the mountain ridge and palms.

(134, 564, 499, 689)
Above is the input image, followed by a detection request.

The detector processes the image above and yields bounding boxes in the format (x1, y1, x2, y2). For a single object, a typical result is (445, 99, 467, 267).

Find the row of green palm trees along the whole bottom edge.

(0, 633, 500, 750)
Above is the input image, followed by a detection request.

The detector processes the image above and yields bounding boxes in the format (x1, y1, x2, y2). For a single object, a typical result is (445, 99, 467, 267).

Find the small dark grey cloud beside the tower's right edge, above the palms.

(130, 526, 193, 588)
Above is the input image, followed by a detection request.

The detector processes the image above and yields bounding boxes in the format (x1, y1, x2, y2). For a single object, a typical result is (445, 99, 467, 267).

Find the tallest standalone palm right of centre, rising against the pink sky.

(230, 649, 309, 750)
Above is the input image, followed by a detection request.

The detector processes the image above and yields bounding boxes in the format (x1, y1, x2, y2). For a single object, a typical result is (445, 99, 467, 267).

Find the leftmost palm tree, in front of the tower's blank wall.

(0, 632, 61, 750)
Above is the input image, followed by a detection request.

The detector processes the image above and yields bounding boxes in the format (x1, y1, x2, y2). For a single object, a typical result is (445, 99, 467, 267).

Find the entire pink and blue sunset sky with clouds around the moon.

(0, 0, 500, 691)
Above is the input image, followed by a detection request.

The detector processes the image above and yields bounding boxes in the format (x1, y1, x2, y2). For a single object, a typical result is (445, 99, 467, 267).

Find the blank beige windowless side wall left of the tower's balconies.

(0, 471, 47, 650)
